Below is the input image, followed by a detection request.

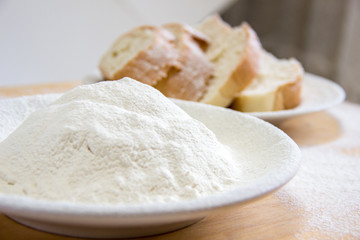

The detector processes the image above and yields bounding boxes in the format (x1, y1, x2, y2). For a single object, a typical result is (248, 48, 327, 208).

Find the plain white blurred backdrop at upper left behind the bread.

(0, 0, 232, 86)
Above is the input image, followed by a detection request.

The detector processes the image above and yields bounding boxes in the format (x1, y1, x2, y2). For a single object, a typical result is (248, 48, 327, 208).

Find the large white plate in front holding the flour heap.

(0, 95, 300, 238)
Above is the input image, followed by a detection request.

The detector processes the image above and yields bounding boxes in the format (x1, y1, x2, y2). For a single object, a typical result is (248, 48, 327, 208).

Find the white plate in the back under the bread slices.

(248, 73, 345, 123)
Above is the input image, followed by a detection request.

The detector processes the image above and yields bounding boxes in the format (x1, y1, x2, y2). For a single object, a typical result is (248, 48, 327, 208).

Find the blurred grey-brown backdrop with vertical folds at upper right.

(222, 0, 360, 103)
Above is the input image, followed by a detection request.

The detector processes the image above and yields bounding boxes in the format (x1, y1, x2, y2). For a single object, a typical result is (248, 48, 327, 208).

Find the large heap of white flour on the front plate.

(0, 78, 240, 204)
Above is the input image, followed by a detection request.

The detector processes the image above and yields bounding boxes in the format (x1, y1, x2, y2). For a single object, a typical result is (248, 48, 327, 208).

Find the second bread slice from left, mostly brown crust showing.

(155, 23, 214, 101)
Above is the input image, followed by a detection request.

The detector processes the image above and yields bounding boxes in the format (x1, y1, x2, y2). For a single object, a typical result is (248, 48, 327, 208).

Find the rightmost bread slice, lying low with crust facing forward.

(230, 50, 304, 112)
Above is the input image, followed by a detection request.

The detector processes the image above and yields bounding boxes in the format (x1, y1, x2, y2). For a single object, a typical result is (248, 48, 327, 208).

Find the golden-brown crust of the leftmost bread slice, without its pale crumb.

(99, 26, 180, 86)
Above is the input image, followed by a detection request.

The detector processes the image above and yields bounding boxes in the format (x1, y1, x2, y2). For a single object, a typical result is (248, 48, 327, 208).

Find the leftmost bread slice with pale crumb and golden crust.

(99, 26, 179, 86)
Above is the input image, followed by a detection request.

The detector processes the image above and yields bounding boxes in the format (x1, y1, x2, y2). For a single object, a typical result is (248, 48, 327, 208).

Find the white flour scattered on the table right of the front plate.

(276, 104, 360, 239)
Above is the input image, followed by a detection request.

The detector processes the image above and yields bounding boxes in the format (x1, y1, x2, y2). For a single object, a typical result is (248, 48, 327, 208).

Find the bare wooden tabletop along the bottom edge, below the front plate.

(0, 195, 301, 240)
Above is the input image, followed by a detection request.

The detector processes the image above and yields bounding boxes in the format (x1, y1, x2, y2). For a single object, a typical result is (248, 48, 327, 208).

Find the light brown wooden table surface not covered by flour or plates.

(0, 82, 360, 240)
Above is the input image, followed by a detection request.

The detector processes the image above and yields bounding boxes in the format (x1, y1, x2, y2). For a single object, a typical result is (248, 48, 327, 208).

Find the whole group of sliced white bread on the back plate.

(99, 15, 303, 112)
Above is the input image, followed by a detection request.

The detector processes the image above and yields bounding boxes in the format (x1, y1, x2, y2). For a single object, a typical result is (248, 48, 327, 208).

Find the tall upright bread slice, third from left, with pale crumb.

(196, 15, 261, 107)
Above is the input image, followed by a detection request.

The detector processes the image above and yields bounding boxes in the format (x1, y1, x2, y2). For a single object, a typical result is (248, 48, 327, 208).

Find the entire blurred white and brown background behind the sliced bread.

(0, 0, 360, 103)
